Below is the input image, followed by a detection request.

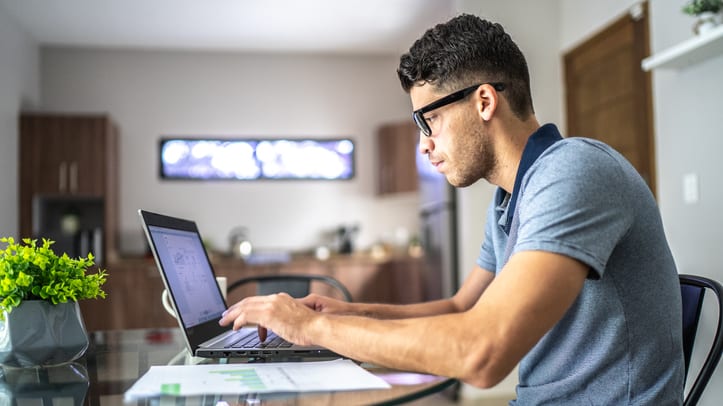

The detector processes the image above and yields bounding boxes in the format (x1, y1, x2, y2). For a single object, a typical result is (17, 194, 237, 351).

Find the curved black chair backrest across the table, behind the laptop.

(228, 274, 352, 302)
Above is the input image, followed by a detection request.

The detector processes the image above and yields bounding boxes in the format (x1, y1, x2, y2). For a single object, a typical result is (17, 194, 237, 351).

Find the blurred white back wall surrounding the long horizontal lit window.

(42, 48, 418, 255)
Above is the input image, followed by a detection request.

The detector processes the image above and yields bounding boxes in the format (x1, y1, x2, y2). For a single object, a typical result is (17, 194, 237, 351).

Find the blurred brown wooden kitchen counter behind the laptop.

(79, 254, 429, 331)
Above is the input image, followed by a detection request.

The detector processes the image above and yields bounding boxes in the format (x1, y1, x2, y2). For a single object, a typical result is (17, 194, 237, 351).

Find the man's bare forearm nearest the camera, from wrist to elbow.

(305, 313, 506, 386)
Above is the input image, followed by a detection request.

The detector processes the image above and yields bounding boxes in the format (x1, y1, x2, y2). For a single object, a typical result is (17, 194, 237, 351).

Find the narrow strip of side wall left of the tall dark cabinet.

(0, 6, 39, 237)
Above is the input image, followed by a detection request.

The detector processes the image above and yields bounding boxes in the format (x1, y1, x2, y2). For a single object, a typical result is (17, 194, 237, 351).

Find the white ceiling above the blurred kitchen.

(0, 0, 455, 54)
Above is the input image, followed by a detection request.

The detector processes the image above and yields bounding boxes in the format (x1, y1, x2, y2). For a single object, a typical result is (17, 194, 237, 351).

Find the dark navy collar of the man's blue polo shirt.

(499, 124, 562, 235)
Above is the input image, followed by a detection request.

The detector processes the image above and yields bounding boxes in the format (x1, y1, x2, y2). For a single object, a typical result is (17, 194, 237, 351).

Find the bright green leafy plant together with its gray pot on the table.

(0, 237, 107, 367)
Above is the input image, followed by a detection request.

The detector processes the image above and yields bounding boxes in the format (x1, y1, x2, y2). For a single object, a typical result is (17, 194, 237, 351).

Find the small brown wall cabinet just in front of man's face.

(377, 120, 419, 195)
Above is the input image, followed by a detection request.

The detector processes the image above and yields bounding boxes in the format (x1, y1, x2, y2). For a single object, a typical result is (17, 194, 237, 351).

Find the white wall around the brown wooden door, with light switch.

(561, 0, 723, 406)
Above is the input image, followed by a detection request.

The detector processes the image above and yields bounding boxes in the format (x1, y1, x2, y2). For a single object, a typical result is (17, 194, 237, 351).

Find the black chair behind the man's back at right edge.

(679, 275, 723, 406)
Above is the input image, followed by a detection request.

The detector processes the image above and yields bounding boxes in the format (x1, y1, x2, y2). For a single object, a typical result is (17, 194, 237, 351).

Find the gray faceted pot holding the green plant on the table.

(0, 300, 88, 367)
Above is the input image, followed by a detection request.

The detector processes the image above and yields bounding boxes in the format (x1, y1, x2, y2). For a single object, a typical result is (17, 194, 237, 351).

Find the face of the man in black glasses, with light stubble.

(410, 84, 497, 187)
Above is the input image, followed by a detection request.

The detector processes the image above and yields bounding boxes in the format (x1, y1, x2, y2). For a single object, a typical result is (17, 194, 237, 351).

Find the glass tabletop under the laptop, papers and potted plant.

(0, 329, 457, 406)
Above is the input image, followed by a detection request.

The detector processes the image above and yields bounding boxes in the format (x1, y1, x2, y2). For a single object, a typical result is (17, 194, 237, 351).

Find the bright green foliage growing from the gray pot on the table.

(0, 237, 108, 320)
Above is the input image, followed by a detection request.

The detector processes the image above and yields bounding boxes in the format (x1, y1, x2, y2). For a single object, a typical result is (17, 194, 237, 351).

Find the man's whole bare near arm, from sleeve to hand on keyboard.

(223, 251, 588, 387)
